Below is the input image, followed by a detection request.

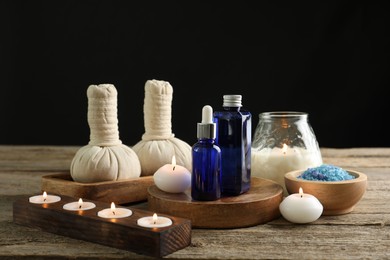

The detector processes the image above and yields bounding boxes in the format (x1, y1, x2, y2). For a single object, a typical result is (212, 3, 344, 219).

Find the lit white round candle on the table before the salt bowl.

(279, 188, 323, 223)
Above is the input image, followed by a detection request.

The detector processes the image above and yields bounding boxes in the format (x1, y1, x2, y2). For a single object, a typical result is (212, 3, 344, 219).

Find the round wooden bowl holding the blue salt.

(284, 170, 367, 215)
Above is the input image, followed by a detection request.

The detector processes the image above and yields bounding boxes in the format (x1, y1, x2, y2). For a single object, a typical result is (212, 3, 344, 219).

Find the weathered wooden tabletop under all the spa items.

(0, 145, 390, 259)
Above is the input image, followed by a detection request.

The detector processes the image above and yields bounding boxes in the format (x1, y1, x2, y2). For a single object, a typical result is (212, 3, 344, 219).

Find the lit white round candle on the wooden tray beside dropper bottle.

(153, 156, 191, 193)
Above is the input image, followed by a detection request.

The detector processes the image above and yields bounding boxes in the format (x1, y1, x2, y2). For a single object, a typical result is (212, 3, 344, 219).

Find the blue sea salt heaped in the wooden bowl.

(297, 164, 355, 181)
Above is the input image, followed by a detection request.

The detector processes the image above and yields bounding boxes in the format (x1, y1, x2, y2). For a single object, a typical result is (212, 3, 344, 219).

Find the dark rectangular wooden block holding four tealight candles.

(13, 195, 191, 257)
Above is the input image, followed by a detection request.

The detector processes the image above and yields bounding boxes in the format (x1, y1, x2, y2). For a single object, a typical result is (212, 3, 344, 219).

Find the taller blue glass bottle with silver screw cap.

(214, 95, 252, 196)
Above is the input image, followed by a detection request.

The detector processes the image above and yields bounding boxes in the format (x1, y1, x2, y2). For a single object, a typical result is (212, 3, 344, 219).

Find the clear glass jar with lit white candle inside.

(251, 111, 322, 196)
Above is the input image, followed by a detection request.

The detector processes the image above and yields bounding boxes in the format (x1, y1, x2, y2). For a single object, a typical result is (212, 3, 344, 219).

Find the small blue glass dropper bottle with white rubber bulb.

(191, 105, 221, 200)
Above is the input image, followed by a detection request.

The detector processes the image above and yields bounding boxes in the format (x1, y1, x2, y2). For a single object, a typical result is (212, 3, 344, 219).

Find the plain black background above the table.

(0, 1, 390, 147)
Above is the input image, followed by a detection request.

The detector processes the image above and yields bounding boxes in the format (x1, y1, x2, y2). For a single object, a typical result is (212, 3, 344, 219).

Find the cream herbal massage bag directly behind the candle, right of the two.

(132, 79, 192, 176)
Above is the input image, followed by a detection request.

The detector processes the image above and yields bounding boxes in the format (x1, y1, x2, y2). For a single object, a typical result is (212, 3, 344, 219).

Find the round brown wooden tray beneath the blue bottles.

(148, 177, 283, 228)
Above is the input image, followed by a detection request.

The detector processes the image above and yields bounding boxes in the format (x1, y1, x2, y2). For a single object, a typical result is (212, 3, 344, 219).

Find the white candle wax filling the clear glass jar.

(251, 144, 322, 196)
